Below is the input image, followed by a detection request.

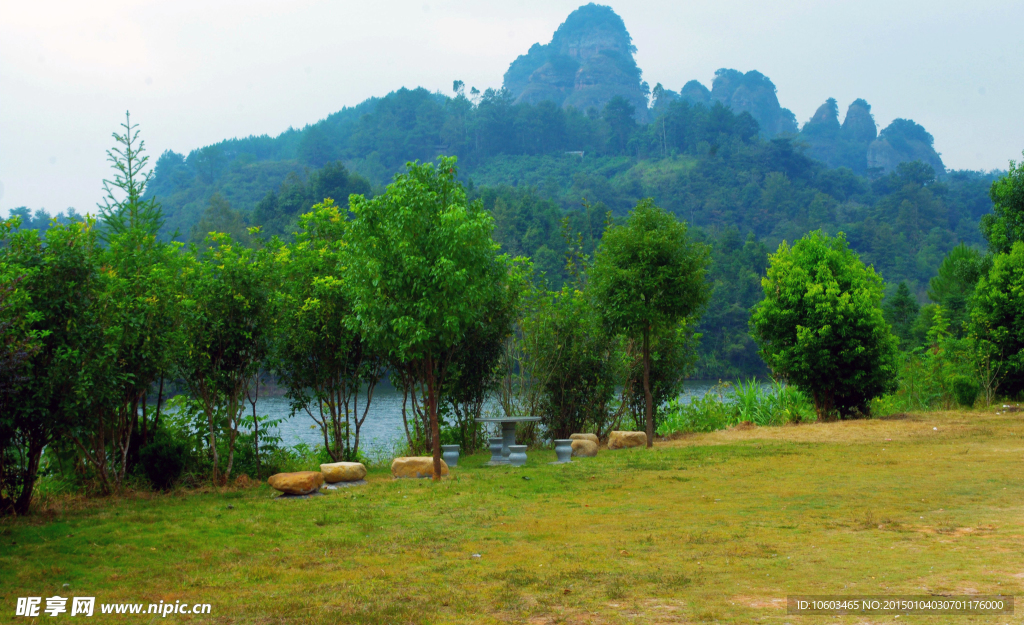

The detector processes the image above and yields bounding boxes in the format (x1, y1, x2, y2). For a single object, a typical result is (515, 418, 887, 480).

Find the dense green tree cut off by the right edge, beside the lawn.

(971, 241, 1024, 395)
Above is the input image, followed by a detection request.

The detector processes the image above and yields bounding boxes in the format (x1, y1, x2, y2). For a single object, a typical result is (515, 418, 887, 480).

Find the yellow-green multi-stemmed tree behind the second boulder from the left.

(273, 199, 386, 462)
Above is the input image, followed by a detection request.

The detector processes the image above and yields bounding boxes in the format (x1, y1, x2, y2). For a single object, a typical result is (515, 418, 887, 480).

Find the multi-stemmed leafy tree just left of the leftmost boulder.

(175, 233, 273, 484)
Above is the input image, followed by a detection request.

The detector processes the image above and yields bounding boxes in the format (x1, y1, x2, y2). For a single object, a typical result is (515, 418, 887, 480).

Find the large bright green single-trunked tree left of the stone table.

(349, 158, 512, 480)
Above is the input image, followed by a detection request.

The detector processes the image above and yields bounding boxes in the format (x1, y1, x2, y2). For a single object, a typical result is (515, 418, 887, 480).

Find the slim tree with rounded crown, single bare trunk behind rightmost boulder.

(592, 199, 711, 447)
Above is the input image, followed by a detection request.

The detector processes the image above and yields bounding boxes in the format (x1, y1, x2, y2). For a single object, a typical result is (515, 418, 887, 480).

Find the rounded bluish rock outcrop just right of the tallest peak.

(680, 68, 797, 137)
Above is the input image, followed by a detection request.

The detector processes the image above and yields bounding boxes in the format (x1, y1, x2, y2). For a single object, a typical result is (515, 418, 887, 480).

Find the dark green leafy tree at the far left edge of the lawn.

(0, 219, 108, 514)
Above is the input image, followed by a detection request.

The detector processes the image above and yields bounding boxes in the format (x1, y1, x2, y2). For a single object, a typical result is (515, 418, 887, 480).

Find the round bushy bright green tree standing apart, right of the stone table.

(751, 231, 897, 420)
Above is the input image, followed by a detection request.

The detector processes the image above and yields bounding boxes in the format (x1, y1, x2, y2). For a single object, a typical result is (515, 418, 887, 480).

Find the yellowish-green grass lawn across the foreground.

(0, 410, 1024, 624)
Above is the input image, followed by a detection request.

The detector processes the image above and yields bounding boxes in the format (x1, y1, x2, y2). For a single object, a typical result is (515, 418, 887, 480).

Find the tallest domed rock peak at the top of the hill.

(504, 4, 648, 121)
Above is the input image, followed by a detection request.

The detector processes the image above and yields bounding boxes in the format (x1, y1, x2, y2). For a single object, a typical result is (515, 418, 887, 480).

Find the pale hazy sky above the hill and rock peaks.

(0, 0, 1024, 212)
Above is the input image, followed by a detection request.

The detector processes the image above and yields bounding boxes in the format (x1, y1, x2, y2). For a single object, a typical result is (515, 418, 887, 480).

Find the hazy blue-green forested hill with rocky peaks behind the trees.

(130, 4, 994, 376)
